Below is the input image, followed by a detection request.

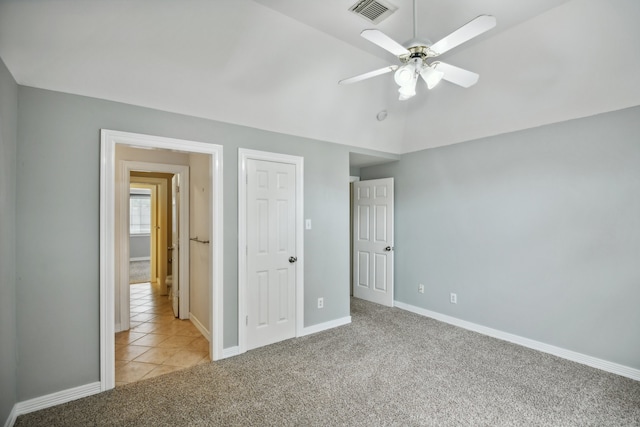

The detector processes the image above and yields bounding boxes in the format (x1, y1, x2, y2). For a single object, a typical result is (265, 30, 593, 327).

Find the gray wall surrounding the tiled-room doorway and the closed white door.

(17, 86, 349, 400)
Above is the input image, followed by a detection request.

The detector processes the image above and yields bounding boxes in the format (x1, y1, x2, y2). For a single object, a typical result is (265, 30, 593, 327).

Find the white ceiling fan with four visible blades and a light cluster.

(338, 0, 496, 101)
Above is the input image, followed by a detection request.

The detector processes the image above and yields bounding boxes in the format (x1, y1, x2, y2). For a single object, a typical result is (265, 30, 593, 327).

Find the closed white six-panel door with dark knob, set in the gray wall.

(246, 159, 297, 350)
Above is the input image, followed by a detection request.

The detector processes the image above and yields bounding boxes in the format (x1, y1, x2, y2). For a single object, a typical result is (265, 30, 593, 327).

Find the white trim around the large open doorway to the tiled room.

(100, 129, 224, 391)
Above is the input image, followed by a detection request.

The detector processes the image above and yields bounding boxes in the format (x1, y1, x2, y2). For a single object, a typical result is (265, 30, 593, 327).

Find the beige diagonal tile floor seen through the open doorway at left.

(116, 283, 209, 387)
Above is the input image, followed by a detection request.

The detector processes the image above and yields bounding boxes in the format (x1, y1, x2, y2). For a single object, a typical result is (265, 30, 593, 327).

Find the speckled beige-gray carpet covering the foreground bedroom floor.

(16, 300, 640, 426)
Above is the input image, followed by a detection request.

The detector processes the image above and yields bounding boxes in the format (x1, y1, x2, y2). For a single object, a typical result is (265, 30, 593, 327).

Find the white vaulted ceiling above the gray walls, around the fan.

(0, 0, 640, 154)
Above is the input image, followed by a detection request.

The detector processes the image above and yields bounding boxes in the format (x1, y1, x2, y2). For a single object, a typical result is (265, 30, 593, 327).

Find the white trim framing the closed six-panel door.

(238, 148, 304, 353)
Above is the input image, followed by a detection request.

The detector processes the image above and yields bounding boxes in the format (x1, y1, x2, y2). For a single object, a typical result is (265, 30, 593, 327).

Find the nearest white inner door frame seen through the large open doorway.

(116, 160, 189, 330)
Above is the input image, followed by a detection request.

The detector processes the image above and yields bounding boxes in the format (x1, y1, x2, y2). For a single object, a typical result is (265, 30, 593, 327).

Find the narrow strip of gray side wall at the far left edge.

(0, 59, 18, 424)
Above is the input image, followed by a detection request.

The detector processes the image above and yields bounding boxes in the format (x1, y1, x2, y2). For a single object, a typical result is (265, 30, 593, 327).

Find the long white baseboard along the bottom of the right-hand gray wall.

(394, 301, 640, 381)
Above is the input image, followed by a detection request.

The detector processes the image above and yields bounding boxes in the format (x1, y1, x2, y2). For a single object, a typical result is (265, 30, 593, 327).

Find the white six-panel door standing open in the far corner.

(353, 178, 393, 307)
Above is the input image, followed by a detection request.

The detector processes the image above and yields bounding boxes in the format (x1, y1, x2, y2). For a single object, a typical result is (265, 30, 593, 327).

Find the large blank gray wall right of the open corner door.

(361, 107, 640, 369)
